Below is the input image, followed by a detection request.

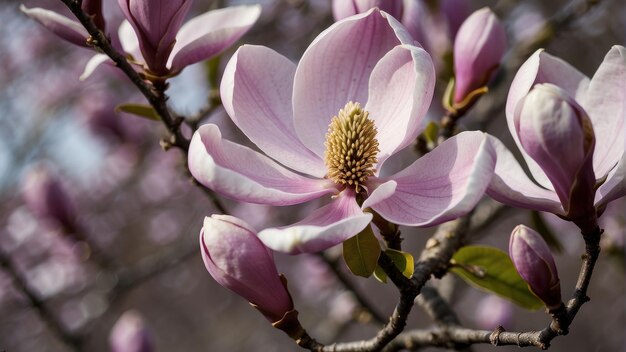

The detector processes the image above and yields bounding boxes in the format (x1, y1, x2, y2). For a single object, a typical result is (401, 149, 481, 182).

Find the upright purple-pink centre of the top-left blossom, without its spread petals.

(118, 0, 191, 74)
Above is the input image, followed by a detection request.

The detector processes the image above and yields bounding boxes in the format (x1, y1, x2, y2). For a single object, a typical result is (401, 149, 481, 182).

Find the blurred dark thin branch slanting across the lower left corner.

(0, 248, 83, 351)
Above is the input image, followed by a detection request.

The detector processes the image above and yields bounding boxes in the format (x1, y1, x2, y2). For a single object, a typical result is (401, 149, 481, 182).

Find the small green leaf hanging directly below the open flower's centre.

(343, 225, 380, 277)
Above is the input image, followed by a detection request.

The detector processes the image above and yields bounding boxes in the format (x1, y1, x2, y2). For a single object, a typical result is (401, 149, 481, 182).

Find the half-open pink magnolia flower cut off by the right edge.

(488, 46, 626, 231)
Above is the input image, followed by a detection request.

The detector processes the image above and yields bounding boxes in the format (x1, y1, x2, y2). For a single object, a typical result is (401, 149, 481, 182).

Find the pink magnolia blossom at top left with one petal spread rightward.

(118, 0, 261, 75)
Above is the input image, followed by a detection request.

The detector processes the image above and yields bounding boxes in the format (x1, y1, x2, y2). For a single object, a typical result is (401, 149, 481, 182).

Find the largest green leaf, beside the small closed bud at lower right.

(451, 246, 544, 310)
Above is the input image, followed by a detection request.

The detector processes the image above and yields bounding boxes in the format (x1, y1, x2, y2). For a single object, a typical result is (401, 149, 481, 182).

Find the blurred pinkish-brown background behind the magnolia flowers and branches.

(0, 0, 626, 352)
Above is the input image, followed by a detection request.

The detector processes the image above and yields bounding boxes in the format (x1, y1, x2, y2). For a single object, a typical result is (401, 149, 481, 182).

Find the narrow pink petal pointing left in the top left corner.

(20, 5, 89, 47)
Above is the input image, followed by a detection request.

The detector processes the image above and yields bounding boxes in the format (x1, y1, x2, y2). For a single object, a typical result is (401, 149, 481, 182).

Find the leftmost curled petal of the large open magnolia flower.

(189, 124, 337, 205)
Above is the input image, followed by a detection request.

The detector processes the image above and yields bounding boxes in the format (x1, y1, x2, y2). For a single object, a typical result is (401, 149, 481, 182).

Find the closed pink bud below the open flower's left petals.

(200, 215, 293, 323)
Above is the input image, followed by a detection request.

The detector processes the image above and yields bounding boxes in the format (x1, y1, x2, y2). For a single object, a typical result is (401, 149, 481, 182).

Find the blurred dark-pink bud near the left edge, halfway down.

(23, 166, 76, 231)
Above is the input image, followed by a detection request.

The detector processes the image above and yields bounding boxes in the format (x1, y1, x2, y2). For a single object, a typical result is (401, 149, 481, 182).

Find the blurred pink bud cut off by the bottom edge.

(109, 310, 154, 352)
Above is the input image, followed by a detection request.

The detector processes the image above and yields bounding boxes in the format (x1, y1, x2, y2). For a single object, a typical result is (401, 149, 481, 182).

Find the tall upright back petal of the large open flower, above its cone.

(293, 9, 412, 157)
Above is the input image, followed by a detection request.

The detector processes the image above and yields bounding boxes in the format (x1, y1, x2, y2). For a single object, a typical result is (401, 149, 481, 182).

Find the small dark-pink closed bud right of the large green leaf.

(509, 225, 561, 309)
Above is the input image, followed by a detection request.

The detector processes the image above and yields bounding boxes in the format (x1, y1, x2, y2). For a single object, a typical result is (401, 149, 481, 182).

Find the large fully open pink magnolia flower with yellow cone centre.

(189, 9, 495, 254)
